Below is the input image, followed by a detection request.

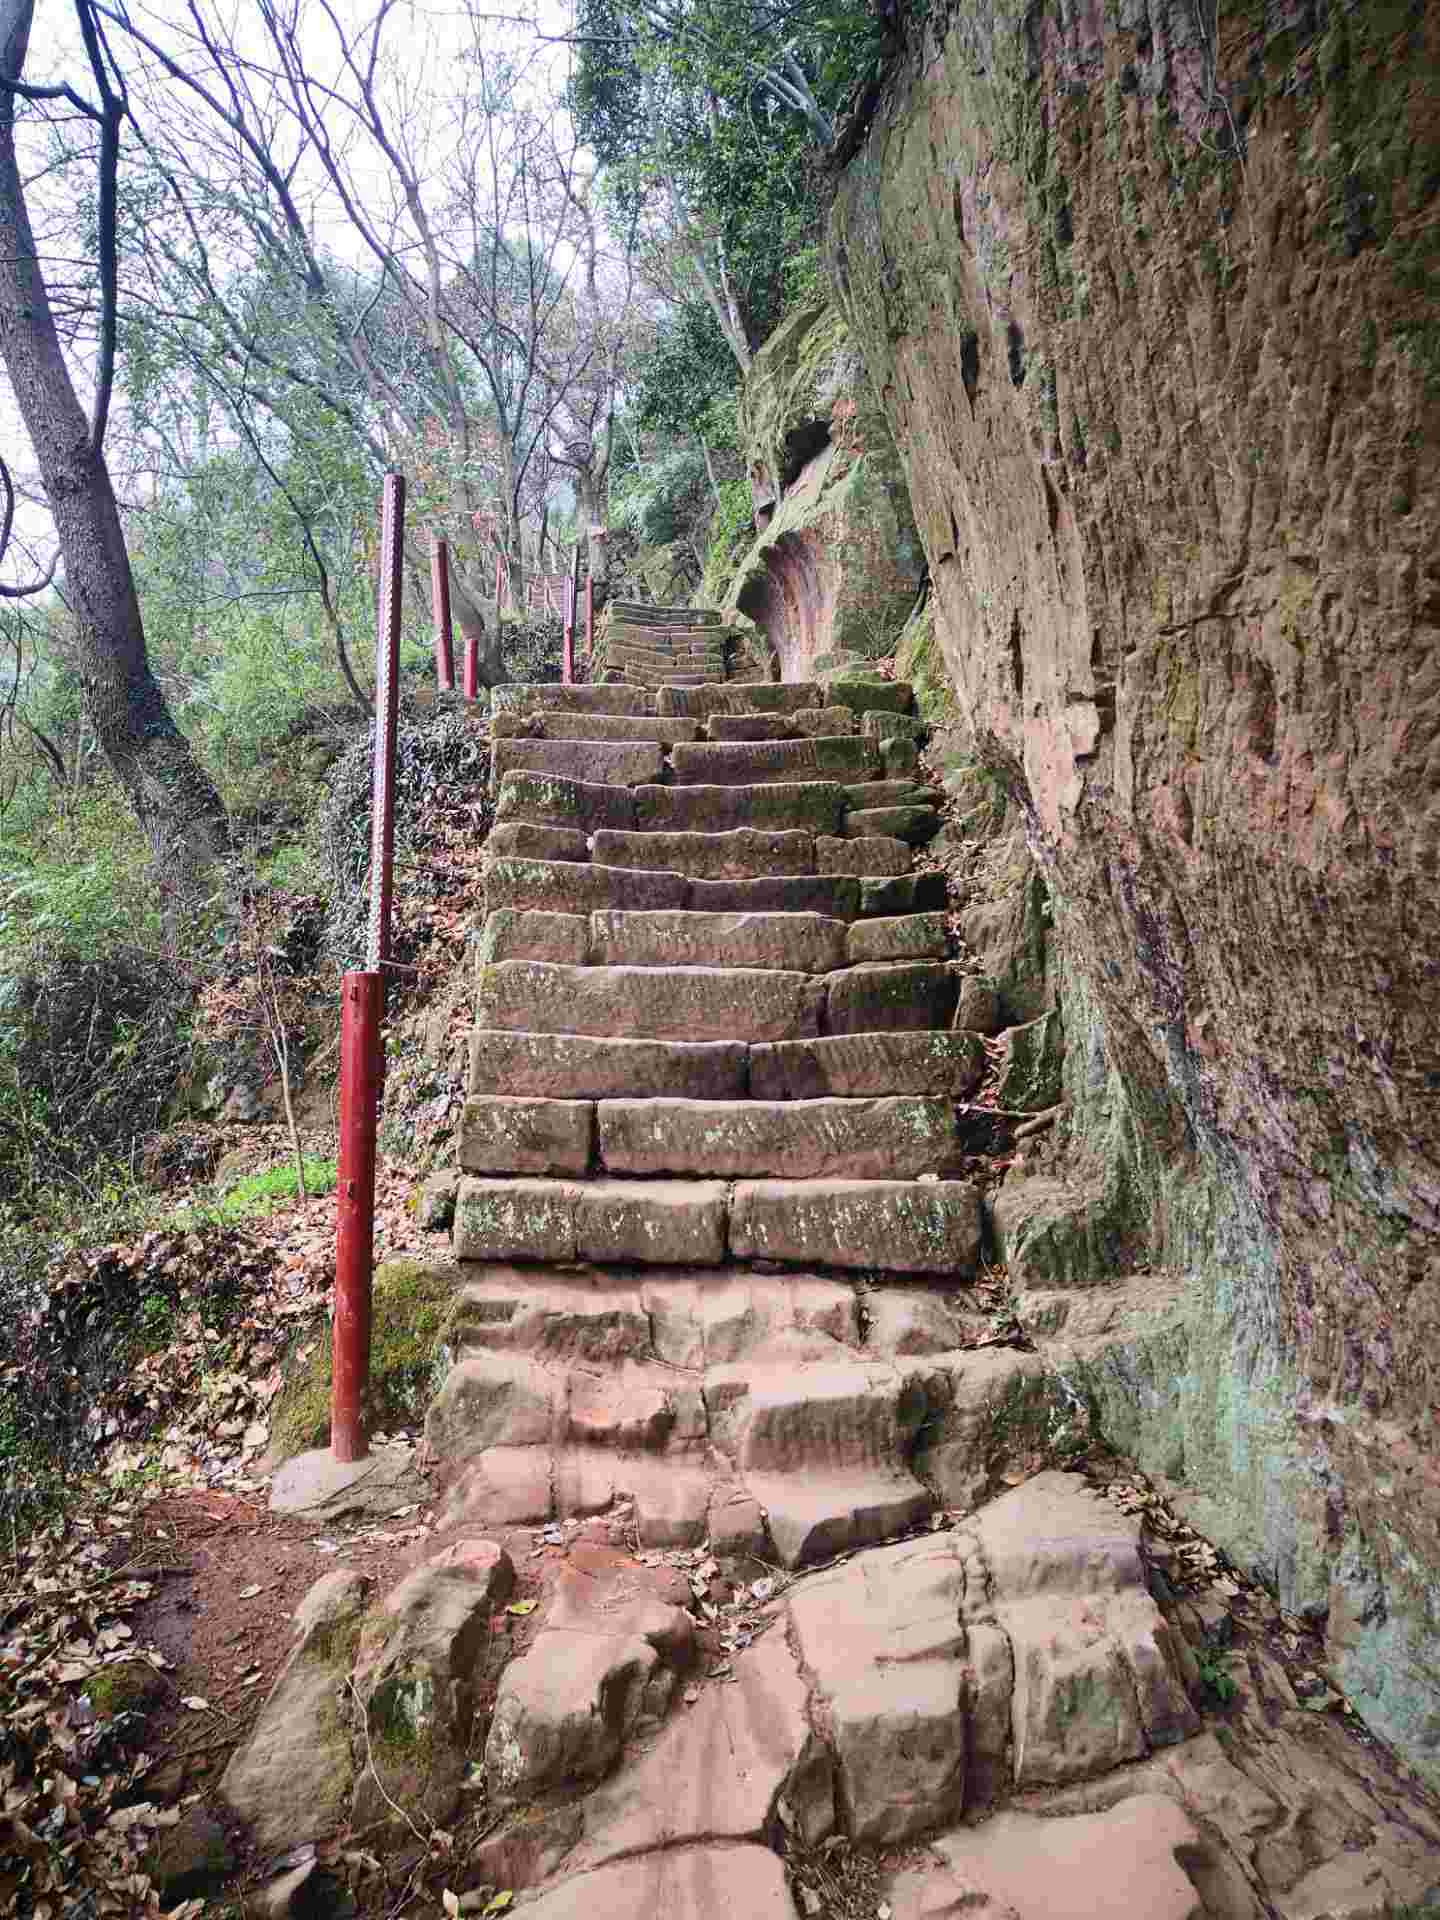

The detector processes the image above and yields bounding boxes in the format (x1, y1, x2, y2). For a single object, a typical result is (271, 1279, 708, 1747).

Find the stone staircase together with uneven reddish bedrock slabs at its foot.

(223, 618, 1440, 1920)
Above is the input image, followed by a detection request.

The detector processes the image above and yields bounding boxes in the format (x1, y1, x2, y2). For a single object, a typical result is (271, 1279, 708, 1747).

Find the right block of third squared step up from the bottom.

(749, 1036, 985, 1100)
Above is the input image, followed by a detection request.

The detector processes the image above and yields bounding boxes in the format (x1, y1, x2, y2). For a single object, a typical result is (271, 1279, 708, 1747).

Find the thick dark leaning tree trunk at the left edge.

(0, 0, 228, 874)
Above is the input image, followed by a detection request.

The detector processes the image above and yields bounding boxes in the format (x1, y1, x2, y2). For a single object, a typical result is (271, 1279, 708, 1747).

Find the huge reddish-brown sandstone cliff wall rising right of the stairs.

(831, 0, 1440, 1778)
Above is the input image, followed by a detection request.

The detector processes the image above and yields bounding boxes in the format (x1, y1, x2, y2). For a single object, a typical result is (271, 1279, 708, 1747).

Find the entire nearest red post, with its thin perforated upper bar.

(330, 474, 405, 1461)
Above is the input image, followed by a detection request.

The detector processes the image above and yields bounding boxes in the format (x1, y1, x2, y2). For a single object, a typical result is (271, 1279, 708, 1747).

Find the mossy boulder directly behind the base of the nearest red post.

(267, 1260, 461, 1467)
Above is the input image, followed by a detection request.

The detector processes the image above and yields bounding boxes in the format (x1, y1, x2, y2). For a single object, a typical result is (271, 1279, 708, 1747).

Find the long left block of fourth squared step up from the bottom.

(476, 960, 821, 1041)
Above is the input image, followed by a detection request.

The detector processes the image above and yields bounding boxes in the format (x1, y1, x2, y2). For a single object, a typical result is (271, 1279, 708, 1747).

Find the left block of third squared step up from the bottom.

(468, 1027, 748, 1100)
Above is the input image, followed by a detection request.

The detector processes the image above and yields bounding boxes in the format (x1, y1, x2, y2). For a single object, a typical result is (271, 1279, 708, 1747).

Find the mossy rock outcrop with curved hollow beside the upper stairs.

(726, 303, 924, 680)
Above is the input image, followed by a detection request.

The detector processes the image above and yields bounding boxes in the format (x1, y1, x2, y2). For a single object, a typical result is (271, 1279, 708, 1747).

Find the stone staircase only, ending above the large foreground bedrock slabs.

(428, 609, 1075, 1567)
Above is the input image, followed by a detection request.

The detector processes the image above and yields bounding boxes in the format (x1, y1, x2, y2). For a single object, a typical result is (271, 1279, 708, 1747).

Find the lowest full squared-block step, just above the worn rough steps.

(453, 1177, 979, 1279)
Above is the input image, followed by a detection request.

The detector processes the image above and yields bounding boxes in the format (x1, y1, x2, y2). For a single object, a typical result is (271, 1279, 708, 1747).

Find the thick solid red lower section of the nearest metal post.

(330, 973, 384, 1461)
